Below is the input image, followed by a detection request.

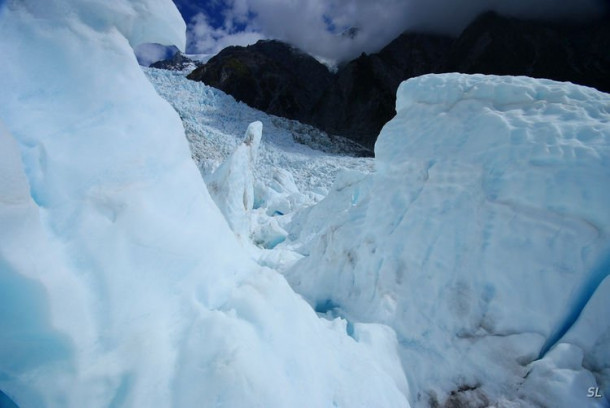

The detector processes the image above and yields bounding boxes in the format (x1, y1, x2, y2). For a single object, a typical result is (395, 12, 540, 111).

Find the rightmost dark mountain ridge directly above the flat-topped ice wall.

(446, 12, 610, 92)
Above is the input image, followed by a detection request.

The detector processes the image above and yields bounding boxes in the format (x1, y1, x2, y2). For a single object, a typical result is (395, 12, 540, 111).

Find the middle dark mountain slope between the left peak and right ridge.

(308, 33, 453, 149)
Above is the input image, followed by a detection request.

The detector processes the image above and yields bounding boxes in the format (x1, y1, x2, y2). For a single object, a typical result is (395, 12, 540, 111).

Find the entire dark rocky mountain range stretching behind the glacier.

(188, 12, 610, 149)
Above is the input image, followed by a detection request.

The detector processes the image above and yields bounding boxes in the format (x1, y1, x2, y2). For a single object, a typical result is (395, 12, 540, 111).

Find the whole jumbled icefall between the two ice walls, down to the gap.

(144, 68, 373, 262)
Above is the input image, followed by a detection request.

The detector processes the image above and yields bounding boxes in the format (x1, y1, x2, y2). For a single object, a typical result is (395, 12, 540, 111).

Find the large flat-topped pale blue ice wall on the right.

(287, 74, 610, 407)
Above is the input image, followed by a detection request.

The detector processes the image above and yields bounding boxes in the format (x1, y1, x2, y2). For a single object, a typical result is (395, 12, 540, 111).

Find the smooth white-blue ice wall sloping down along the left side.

(0, 0, 408, 408)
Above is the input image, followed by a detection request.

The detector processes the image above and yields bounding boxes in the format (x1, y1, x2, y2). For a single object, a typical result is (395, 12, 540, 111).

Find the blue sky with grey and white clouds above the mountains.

(139, 0, 610, 62)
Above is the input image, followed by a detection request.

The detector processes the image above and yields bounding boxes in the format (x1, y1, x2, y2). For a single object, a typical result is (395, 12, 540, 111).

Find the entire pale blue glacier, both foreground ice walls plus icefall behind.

(0, 0, 610, 408)
